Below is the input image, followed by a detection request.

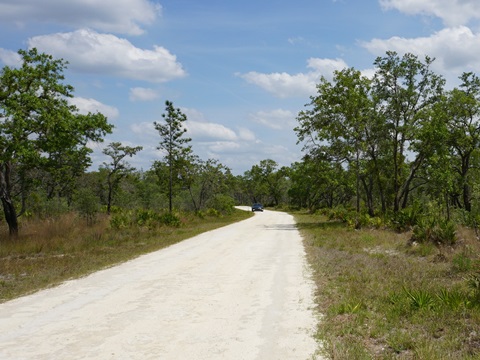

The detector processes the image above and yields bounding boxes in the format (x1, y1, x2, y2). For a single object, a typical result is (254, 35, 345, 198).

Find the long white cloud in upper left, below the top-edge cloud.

(28, 29, 186, 82)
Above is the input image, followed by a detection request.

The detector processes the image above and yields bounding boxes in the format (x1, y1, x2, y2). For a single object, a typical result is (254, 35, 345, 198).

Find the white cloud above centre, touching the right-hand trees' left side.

(239, 58, 346, 98)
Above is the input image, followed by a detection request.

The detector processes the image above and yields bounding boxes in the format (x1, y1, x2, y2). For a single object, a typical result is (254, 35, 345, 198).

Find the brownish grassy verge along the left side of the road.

(0, 210, 252, 302)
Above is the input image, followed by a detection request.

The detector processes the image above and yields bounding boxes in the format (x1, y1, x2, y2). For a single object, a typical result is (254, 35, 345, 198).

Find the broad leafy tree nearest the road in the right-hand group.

(295, 68, 376, 218)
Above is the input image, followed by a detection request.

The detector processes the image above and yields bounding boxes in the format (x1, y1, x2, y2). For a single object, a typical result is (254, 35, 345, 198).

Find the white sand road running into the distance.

(0, 211, 318, 360)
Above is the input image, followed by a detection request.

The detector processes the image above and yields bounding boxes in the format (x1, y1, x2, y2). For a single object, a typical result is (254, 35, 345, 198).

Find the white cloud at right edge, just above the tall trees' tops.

(362, 26, 480, 77)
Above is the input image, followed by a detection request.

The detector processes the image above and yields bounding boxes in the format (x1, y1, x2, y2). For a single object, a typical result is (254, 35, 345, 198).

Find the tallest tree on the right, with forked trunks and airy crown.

(373, 51, 445, 213)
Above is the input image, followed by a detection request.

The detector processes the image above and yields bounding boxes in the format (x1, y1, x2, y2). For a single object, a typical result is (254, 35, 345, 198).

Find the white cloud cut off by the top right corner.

(380, 0, 480, 26)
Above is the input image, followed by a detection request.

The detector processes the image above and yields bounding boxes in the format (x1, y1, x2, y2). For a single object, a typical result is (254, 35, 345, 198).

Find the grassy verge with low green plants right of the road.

(295, 213, 480, 360)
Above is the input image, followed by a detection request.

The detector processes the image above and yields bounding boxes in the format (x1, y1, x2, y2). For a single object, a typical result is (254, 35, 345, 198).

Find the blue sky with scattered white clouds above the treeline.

(0, 0, 480, 174)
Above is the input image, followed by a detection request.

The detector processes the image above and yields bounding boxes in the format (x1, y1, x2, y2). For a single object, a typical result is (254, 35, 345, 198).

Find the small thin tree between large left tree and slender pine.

(99, 142, 143, 215)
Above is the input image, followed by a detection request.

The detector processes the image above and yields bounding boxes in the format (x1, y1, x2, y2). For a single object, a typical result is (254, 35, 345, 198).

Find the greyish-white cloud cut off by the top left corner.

(0, 0, 161, 35)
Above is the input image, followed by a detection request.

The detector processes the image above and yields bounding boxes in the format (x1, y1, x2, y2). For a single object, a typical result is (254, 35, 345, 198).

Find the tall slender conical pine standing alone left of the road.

(154, 100, 192, 212)
